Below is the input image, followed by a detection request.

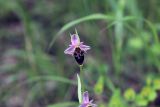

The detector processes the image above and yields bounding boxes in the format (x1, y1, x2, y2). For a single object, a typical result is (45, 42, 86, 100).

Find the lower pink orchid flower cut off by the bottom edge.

(79, 91, 97, 107)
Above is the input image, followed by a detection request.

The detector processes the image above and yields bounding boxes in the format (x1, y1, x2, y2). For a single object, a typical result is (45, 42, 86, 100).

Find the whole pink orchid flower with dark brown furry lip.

(64, 31, 90, 65)
